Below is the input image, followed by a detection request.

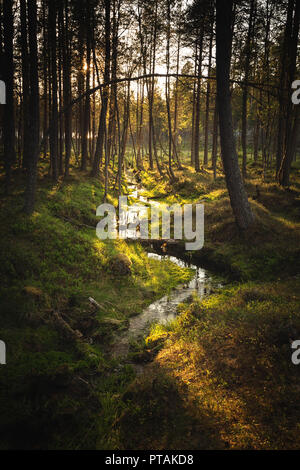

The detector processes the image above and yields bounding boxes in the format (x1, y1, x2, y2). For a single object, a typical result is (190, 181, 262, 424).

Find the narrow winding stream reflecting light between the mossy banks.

(110, 174, 222, 358)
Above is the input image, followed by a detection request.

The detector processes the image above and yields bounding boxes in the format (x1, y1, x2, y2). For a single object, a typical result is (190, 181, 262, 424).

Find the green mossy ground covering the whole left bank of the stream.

(0, 166, 191, 449)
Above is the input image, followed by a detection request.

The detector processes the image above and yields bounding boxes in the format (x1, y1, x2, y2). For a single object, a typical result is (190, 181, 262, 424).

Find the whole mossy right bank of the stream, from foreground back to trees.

(114, 163, 300, 450)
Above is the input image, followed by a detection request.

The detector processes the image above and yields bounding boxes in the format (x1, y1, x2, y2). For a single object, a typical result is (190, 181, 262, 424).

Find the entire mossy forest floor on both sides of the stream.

(0, 160, 300, 450)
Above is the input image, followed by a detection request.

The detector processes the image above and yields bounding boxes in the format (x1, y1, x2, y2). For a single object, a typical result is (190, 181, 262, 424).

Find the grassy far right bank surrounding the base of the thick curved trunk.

(141, 165, 300, 280)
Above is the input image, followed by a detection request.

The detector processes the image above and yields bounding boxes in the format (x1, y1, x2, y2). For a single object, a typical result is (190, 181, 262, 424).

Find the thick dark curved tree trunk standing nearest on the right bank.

(217, 0, 254, 230)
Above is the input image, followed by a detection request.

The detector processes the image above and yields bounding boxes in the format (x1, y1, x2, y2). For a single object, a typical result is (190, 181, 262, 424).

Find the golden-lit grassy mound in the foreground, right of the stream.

(114, 278, 300, 450)
